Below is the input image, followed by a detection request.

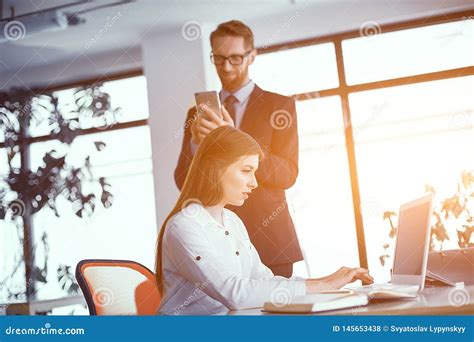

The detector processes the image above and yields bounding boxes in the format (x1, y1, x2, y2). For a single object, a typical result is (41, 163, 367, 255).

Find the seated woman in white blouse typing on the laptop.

(156, 126, 372, 315)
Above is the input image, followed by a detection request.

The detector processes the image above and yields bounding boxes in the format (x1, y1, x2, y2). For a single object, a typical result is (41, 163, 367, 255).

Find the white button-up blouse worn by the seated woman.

(159, 203, 306, 315)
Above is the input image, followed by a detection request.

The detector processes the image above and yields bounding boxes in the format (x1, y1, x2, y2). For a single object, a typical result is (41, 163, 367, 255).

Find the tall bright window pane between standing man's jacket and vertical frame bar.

(288, 96, 358, 277)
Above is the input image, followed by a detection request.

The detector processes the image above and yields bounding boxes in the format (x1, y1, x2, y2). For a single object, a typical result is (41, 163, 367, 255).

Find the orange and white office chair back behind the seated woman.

(76, 259, 161, 316)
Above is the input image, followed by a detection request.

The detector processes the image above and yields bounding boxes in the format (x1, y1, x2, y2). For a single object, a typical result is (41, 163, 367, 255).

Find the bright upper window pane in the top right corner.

(342, 20, 474, 85)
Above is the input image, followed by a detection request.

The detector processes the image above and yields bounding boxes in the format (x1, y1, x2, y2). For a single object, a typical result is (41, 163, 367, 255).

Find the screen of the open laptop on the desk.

(393, 201, 431, 275)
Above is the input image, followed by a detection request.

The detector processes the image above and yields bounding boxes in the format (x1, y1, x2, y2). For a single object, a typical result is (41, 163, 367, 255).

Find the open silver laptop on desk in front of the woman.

(351, 194, 434, 297)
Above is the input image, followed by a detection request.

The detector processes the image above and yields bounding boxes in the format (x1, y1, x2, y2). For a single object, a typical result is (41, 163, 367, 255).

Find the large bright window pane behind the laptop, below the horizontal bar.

(350, 76, 474, 280)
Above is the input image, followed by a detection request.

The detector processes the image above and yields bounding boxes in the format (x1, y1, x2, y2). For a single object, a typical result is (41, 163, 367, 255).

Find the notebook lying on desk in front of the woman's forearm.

(263, 291, 369, 313)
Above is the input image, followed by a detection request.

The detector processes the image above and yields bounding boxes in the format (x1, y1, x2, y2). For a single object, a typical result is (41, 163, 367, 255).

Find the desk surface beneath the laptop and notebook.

(228, 285, 474, 316)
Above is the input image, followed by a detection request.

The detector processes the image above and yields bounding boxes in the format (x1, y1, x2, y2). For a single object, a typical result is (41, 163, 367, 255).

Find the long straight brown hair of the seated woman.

(155, 126, 263, 295)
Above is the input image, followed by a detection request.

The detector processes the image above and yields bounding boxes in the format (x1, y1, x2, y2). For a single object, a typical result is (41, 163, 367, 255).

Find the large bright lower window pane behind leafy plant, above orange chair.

(31, 126, 157, 299)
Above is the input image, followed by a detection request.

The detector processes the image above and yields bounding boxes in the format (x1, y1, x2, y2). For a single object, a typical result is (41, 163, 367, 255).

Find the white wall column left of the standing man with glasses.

(142, 30, 212, 227)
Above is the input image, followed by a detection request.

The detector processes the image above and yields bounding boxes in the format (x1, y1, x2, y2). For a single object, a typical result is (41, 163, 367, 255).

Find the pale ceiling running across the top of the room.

(0, 0, 472, 88)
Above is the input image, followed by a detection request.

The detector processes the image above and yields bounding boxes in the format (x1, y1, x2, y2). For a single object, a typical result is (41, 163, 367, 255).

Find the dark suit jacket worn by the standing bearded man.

(174, 86, 303, 266)
